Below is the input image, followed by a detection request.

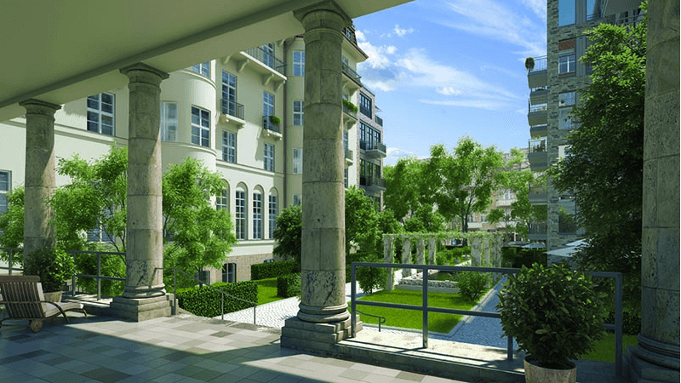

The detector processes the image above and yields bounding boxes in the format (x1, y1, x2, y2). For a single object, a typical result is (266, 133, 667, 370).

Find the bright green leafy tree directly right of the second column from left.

(163, 157, 236, 280)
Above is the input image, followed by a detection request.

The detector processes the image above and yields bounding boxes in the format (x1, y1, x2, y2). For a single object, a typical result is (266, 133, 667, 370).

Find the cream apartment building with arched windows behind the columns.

(0, 27, 385, 283)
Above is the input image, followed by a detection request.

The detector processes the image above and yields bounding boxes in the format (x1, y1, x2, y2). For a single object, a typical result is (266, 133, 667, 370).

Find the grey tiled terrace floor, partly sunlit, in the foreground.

(0, 313, 470, 383)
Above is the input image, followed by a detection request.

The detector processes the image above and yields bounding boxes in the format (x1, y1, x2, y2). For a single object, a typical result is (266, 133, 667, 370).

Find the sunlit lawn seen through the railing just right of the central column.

(348, 290, 474, 333)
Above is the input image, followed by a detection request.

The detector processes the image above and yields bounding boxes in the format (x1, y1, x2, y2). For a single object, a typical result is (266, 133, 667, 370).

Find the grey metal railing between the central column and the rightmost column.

(350, 262, 623, 376)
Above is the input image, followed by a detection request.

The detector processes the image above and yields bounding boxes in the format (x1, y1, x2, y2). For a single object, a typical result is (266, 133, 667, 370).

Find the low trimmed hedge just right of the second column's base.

(177, 281, 258, 318)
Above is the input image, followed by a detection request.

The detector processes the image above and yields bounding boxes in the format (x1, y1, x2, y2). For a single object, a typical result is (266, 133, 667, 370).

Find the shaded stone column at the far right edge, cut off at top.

(627, 0, 680, 382)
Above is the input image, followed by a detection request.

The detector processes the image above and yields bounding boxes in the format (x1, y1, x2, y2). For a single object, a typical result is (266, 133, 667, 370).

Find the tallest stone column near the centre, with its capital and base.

(281, 1, 351, 350)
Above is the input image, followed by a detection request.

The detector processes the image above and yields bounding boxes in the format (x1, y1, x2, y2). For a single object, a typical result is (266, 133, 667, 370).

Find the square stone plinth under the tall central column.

(281, 317, 362, 352)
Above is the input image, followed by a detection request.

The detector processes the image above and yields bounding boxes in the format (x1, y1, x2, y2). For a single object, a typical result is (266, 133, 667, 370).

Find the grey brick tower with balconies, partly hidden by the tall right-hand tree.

(526, 0, 642, 250)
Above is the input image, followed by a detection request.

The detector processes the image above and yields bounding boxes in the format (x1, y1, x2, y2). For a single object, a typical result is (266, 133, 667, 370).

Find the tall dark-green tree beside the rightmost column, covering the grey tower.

(549, 3, 647, 312)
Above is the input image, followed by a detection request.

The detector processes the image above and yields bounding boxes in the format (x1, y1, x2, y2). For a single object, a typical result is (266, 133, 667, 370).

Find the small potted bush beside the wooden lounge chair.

(24, 247, 75, 302)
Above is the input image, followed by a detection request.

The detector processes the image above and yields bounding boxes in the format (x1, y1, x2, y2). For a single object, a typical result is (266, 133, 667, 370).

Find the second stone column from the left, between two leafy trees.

(111, 63, 170, 321)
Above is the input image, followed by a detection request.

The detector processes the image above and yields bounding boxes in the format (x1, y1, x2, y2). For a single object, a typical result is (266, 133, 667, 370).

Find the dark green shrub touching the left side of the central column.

(273, 205, 303, 265)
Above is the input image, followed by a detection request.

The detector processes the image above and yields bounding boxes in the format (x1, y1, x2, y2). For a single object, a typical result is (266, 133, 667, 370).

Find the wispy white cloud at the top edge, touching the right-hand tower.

(442, 0, 546, 56)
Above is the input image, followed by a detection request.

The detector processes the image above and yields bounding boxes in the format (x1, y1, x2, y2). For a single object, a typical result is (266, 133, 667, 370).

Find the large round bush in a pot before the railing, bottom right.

(497, 263, 605, 383)
